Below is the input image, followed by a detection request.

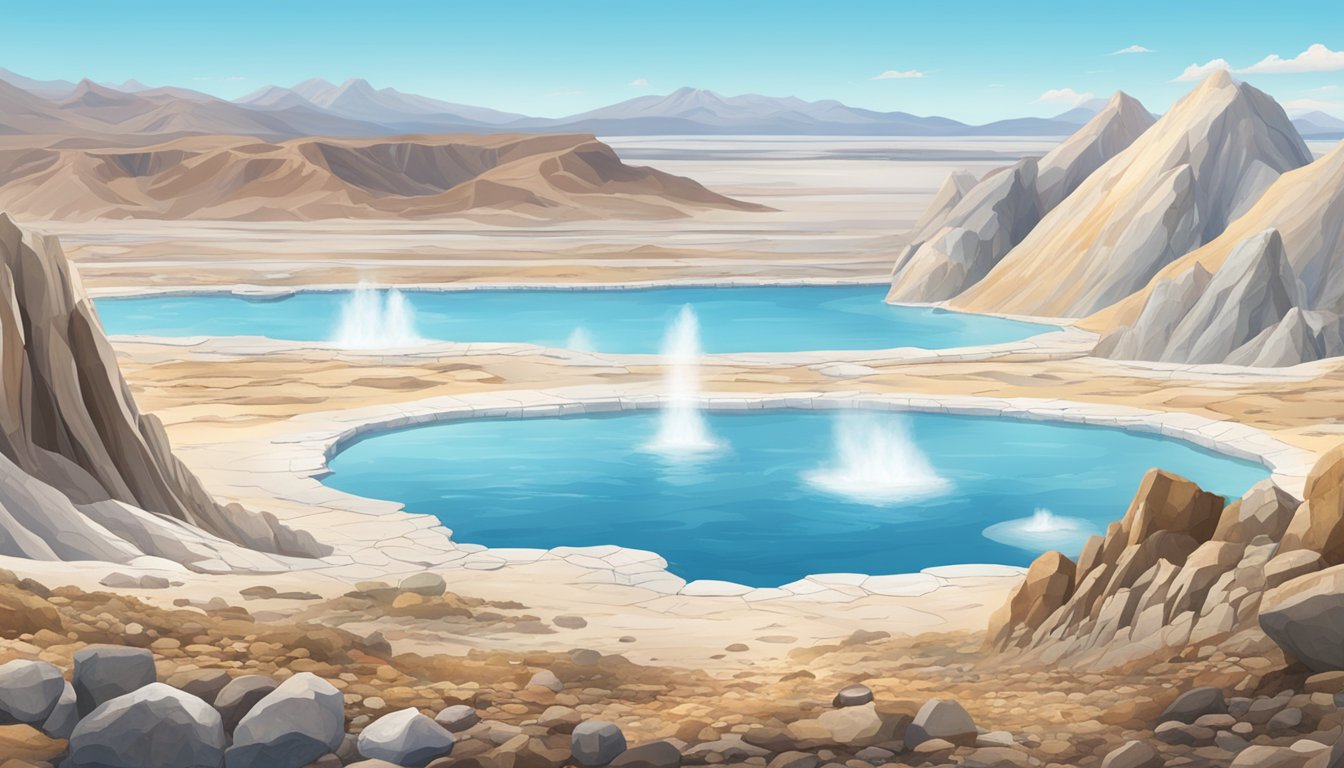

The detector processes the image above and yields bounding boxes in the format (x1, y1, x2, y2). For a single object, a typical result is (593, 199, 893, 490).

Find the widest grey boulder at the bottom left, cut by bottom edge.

(62, 683, 225, 768)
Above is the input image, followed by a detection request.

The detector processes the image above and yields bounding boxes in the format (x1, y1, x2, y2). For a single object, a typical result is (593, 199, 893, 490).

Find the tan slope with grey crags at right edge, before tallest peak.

(1086, 145, 1344, 366)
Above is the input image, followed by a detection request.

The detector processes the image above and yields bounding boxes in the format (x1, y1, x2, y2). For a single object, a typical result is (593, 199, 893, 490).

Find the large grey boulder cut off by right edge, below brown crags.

(1259, 565, 1344, 673)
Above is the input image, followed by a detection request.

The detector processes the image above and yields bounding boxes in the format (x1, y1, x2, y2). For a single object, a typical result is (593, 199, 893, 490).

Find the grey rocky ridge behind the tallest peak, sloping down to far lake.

(887, 93, 1153, 303)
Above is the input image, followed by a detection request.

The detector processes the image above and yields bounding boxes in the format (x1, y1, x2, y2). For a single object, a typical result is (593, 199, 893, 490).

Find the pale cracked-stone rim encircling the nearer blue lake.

(162, 386, 1314, 603)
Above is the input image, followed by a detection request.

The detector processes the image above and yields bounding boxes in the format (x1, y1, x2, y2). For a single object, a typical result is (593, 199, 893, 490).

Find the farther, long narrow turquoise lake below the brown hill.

(97, 285, 1055, 352)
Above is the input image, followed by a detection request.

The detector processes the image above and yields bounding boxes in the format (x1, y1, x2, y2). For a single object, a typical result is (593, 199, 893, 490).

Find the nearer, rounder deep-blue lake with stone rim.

(324, 410, 1269, 586)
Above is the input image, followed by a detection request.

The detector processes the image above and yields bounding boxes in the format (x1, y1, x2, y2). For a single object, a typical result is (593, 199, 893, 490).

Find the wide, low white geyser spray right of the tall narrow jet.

(804, 412, 952, 504)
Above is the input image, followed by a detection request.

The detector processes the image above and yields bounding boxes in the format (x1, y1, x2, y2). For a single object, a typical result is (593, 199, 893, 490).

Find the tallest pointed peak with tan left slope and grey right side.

(952, 71, 1312, 317)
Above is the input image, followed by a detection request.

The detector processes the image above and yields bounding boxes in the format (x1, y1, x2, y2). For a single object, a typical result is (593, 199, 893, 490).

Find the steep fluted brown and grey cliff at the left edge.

(0, 215, 325, 570)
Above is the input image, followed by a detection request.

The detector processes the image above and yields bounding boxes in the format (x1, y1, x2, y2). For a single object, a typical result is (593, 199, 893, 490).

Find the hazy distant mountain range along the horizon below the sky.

(0, 69, 1322, 140)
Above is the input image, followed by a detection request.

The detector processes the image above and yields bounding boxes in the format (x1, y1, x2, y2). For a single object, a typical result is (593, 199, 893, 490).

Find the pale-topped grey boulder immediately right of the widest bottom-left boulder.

(224, 673, 345, 768)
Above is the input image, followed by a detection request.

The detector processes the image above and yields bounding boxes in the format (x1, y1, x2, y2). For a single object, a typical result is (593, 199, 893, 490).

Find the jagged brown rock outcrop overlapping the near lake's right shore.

(989, 462, 1322, 668)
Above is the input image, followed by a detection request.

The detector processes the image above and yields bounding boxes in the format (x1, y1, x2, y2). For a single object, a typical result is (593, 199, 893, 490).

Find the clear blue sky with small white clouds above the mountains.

(10, 0, 1344, 122)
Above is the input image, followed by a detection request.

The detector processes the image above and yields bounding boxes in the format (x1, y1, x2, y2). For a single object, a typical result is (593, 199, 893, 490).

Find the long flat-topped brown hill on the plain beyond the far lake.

(0, 132, 770, 221)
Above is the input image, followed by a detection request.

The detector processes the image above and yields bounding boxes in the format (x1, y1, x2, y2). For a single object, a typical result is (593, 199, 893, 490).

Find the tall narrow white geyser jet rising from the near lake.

(645, 304, 720, 457)
